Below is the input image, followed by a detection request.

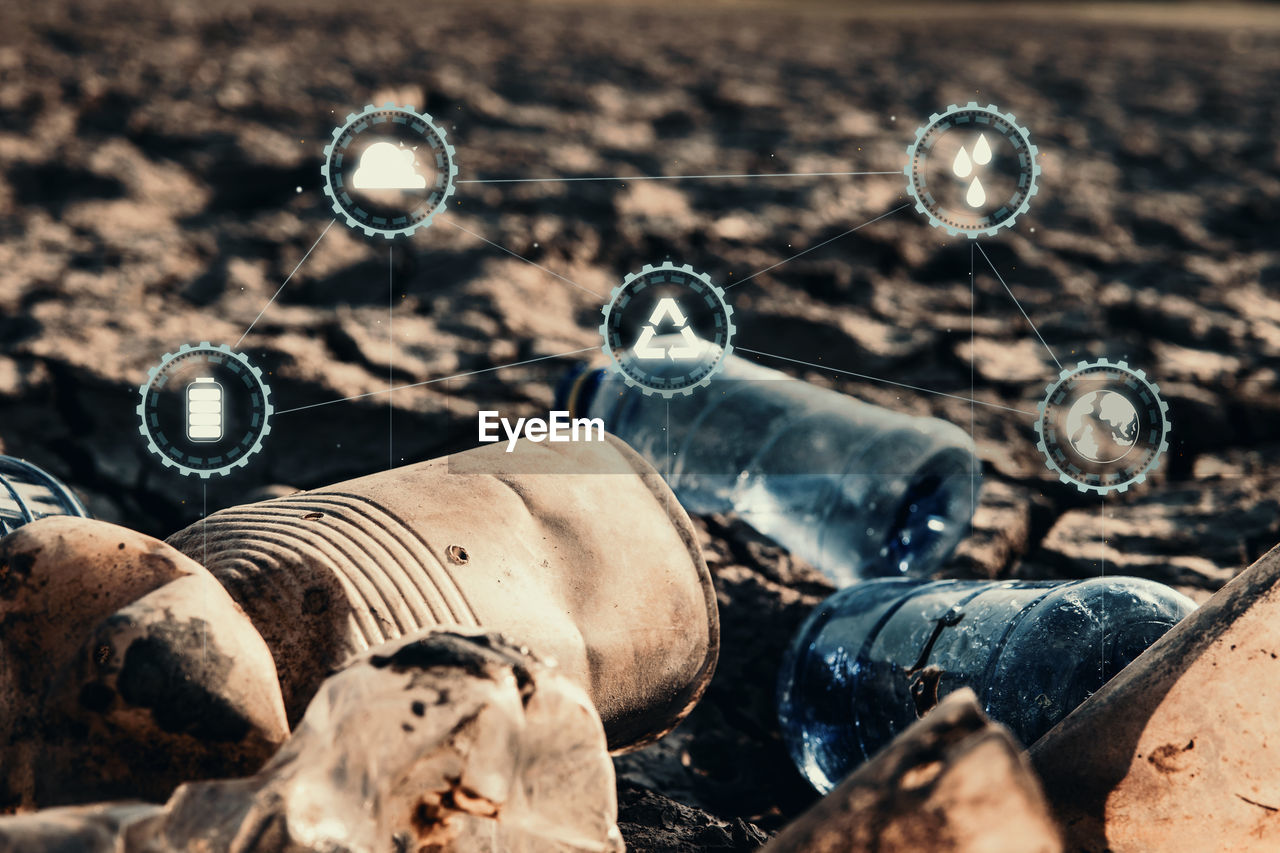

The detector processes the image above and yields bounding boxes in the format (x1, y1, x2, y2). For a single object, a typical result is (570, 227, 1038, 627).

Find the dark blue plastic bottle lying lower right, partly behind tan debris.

(778, 576, 1196, 793)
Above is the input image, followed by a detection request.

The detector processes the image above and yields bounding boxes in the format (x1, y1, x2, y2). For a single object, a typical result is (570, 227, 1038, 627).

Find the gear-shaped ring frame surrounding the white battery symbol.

(136, 341, 275, 479)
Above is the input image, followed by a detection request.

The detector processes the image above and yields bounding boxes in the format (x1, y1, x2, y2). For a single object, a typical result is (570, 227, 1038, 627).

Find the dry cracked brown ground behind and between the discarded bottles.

(0, 0, 1280, 849)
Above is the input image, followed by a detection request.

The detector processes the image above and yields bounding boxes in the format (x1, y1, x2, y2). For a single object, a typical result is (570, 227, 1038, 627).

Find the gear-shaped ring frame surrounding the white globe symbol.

(1036, 359, 1172, 494)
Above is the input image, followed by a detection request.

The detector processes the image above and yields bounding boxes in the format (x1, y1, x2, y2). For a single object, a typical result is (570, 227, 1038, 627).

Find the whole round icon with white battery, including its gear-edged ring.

(137, 342, 273, 479)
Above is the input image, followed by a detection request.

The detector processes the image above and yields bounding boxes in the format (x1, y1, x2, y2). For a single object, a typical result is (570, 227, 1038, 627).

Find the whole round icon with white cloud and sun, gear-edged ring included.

(320, 104, 458, 240)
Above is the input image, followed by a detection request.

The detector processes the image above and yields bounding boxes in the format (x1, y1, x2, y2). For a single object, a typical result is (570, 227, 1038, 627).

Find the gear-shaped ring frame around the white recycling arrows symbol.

(600, 261, 737, 400)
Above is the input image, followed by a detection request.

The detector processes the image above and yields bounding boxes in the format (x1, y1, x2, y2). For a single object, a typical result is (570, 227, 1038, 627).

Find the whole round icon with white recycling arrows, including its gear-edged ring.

(600, 263, 735, 398)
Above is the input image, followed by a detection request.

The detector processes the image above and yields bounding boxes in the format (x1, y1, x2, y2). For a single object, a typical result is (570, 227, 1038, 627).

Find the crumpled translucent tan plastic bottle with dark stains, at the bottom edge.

(0, 631, 626, 853)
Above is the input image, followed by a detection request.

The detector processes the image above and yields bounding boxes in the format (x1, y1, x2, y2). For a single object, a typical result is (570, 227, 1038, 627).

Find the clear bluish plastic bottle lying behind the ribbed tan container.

(557, 355, 982, 585)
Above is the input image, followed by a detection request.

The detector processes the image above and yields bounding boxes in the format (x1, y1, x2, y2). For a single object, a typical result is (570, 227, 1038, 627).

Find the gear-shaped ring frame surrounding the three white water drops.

(902, 101, 1041, 240)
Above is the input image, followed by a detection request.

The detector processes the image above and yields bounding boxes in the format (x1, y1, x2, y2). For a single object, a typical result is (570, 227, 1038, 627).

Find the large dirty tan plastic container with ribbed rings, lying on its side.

(163, 435, 719, 758)
